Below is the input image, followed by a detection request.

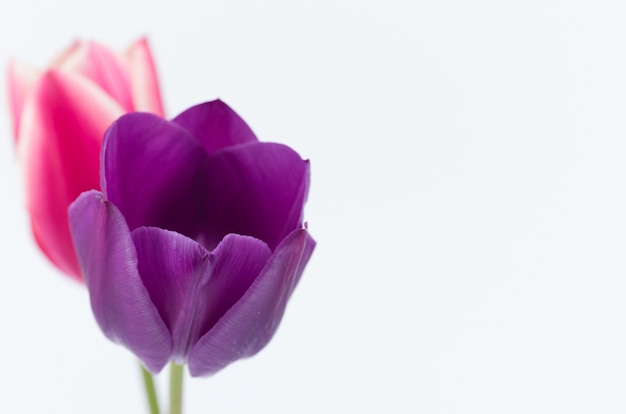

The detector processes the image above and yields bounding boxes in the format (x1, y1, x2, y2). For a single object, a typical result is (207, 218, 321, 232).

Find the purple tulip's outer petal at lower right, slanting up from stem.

(184, 229, 315, 376)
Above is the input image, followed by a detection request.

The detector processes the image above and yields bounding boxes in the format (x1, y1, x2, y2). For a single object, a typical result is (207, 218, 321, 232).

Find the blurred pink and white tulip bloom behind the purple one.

(8, 39, 163, 279)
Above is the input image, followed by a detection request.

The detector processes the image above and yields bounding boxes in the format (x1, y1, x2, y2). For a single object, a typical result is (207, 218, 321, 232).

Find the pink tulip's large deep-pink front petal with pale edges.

(18, 71, 123, 279)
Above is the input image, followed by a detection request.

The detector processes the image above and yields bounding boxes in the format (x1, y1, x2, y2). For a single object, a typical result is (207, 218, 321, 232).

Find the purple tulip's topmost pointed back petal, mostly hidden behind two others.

(172, 100, 257, 154)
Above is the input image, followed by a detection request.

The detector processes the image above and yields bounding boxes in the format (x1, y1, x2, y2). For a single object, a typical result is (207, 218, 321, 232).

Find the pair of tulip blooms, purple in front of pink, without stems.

(9, 40, 315, 376)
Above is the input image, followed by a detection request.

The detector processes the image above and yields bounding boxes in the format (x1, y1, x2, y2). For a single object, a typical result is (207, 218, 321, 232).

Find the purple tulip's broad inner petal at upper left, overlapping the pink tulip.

(101, 113, 206, 237)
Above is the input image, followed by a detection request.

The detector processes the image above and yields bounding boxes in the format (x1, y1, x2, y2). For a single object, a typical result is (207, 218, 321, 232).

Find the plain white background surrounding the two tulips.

(0, 0, 626, 414)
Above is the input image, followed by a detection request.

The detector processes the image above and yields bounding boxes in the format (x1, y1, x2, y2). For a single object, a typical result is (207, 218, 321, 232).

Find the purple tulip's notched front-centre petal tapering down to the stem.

(132, 227, 271, 363)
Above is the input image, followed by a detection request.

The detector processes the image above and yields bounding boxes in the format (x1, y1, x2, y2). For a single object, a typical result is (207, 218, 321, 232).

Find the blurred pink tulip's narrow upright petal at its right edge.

(126, 38, 165, 117)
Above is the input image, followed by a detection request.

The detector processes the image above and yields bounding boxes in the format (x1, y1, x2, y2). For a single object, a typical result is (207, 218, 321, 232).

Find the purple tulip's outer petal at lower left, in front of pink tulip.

(69, 191, 172, 372)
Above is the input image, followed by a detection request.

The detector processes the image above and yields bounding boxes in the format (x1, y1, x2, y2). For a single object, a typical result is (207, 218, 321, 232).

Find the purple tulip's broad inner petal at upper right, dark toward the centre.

(201, 142, 309, 250)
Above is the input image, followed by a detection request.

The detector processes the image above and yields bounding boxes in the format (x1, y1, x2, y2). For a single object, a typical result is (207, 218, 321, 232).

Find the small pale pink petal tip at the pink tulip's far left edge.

(7, 61, 41, 142)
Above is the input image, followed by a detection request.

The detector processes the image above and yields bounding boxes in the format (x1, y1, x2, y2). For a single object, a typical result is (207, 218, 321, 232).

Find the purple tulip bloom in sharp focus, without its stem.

(69, 101, 315, 376)
